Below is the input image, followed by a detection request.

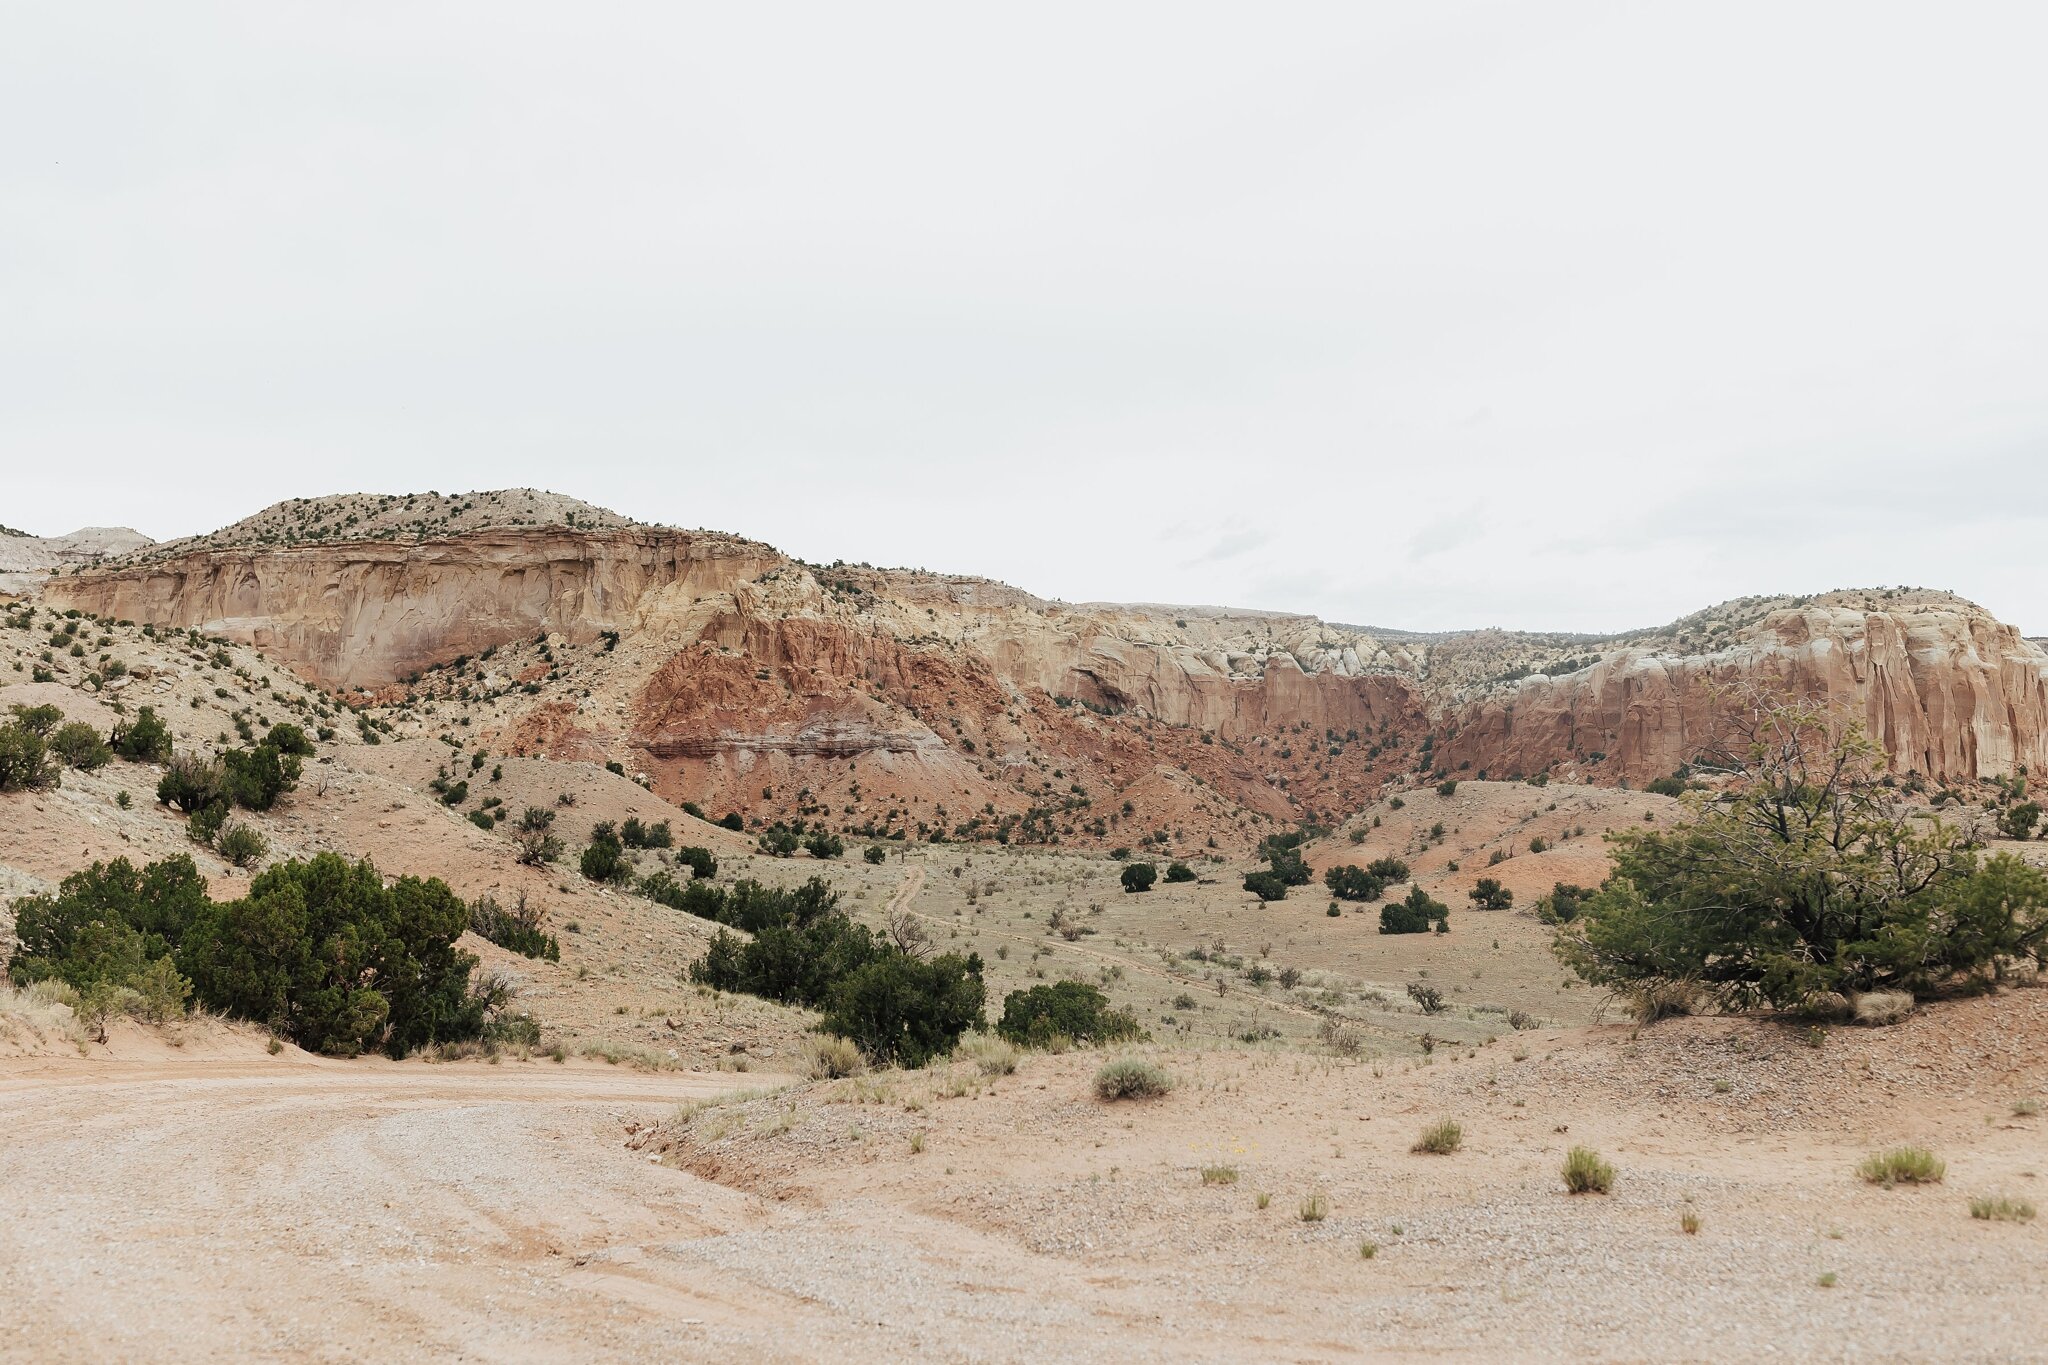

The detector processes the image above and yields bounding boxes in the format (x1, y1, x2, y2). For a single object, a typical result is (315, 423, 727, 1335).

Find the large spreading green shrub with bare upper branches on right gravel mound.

(1556, 706, 2048, 1009)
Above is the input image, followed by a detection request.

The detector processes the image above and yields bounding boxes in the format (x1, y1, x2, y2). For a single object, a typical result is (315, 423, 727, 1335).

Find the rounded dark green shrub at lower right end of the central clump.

(823, 948, 987, 1066)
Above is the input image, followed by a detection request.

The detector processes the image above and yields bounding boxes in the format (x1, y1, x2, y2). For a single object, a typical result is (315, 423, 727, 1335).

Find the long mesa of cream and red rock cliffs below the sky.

(45, 489, 2048, 847)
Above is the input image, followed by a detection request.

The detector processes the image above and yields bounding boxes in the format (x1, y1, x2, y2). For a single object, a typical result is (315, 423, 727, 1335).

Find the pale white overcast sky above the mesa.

(0, 0, 2048, 632)
